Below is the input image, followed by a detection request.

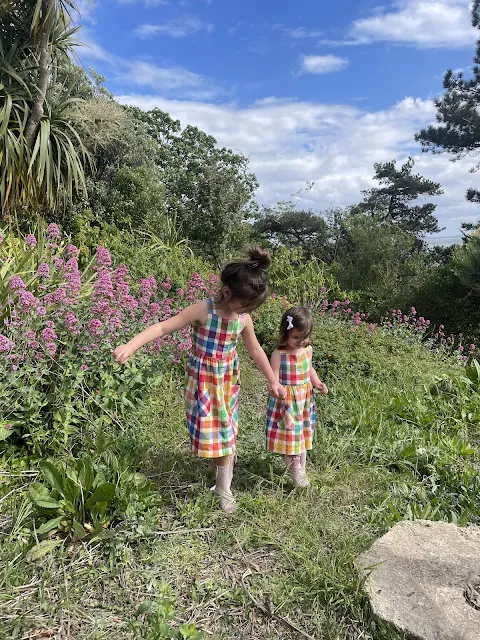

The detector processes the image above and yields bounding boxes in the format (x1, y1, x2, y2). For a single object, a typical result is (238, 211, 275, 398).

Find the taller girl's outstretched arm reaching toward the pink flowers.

(113, 300, 208, 364)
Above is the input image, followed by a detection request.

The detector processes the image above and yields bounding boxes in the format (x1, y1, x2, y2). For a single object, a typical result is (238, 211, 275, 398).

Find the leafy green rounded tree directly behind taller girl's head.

(128, 108, 258, 262)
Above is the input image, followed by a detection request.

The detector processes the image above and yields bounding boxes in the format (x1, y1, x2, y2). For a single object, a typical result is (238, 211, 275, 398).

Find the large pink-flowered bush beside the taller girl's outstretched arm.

(0, 224, 215, 455)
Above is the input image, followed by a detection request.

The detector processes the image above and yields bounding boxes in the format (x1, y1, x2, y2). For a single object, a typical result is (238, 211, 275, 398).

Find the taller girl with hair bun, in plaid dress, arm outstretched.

(114, 247, 285, 513)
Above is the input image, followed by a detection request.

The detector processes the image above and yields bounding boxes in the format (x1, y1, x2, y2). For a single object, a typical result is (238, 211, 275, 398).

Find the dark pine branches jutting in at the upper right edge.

(415, 0, 480, 202)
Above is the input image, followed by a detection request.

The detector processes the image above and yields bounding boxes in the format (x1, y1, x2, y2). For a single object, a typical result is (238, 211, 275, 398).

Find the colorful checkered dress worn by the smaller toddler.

(267, 347, 316, 456)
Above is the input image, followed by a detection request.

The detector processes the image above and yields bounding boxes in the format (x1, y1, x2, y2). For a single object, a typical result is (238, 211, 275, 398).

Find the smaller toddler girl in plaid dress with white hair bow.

(267, 307, 328, 487)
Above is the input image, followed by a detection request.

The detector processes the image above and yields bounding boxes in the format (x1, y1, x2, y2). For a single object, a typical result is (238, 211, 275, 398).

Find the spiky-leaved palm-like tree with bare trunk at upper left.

(0, 0, 88, 214)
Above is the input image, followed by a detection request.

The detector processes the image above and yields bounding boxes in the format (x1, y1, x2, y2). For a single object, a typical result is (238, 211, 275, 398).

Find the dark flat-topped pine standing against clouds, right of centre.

(353, 158, 443, 238)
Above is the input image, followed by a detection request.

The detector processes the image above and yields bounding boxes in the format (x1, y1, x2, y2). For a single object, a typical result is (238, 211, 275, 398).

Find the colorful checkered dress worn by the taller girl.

(185, 300, 245, 458)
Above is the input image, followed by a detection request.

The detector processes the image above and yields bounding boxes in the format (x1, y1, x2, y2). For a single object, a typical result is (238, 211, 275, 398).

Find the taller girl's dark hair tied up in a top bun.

(215, 247, 272, 310)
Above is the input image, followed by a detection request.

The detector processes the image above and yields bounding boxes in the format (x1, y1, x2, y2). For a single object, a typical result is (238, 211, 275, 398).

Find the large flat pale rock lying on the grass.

(357, 520, 480, 640)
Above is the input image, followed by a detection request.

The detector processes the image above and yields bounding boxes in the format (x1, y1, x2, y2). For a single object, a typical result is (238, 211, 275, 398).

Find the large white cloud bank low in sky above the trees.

(117, 95, 479, 236)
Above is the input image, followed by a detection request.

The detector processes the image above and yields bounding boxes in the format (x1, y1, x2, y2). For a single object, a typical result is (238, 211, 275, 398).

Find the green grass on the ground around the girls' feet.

(0, 321, 480, 640)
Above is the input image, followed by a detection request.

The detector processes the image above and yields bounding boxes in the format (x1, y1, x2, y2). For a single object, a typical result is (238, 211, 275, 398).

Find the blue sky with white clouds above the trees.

(80, 0, 480, 237)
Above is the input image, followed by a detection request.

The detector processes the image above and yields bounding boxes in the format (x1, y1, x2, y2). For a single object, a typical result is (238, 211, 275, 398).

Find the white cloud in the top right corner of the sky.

(323, 0, 478, 48)
